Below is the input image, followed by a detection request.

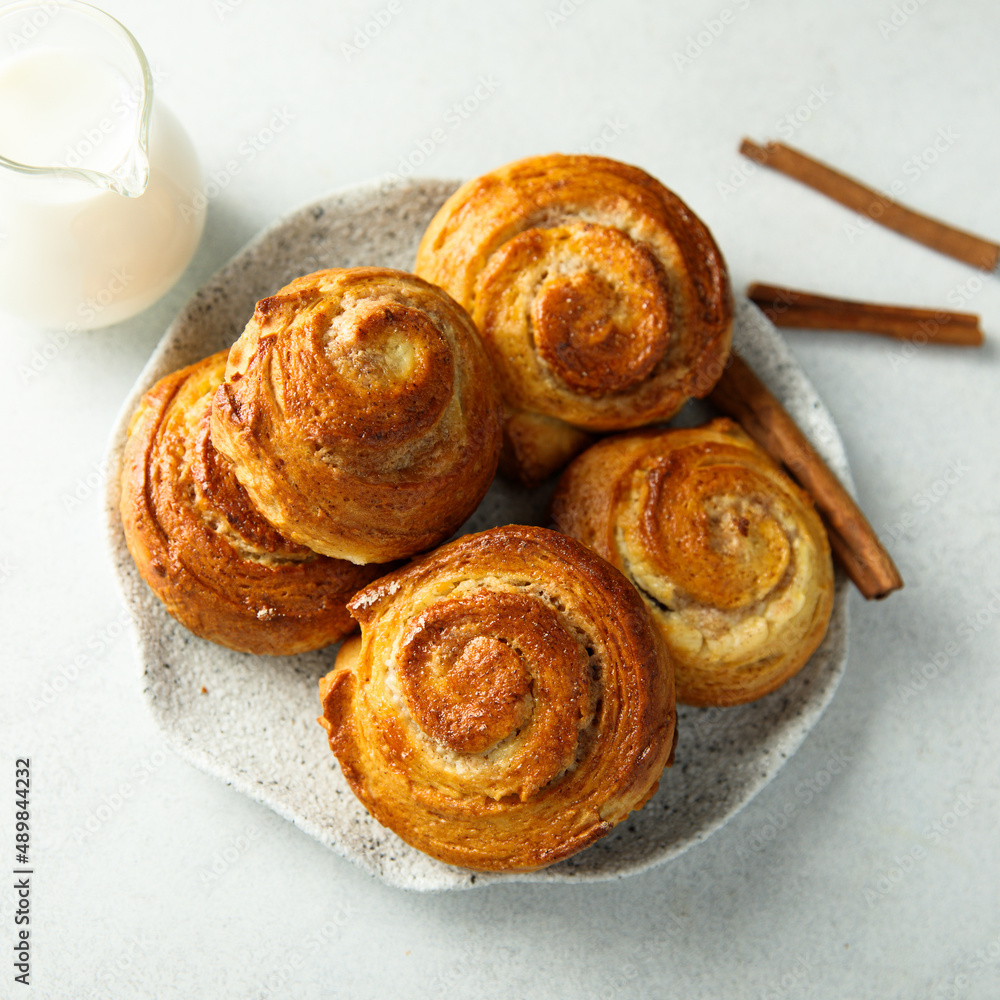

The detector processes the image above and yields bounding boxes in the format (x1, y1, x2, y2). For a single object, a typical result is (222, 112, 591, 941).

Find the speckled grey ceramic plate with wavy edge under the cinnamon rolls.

(107, 180, 850, 890)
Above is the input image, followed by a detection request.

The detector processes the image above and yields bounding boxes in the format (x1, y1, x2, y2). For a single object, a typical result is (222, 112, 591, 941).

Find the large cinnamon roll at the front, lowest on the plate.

(319, 526, 675, 871)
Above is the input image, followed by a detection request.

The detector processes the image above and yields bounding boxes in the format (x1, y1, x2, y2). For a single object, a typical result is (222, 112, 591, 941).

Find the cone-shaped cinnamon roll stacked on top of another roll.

(212, 267, 500, 563)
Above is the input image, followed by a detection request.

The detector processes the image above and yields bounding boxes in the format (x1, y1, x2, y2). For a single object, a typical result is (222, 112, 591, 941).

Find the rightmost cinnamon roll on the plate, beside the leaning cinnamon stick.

(552, 418, 833, 705)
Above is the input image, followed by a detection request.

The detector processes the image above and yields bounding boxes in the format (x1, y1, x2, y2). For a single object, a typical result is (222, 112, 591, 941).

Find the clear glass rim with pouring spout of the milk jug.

(0, 0, 153, 198)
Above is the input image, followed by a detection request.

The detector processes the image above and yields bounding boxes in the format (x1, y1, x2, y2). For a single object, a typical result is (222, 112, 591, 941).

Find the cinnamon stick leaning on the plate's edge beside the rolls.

(709, 353, 903, 600)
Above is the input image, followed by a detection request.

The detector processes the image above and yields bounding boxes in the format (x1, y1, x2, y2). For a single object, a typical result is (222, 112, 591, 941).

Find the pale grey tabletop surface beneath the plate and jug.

(0, 0, 1000, 1000)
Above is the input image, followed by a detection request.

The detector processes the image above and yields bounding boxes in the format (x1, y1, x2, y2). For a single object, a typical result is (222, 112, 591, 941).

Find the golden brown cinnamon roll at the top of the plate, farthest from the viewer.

(415, 154, 733, 481)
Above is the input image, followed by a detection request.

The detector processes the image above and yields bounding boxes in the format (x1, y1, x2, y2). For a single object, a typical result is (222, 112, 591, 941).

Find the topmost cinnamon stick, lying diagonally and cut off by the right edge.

(740, 139, 1000, 271)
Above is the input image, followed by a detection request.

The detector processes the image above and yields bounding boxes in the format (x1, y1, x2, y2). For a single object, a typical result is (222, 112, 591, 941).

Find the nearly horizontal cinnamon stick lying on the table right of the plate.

(747, 282, 983, 347)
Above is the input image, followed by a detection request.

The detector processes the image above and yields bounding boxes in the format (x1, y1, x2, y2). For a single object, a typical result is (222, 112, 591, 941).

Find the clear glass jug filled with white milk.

(0, 0, 205, 332)
